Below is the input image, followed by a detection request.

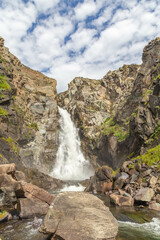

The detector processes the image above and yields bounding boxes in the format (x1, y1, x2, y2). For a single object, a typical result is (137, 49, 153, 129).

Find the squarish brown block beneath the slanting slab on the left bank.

(17, 198, 49, 218)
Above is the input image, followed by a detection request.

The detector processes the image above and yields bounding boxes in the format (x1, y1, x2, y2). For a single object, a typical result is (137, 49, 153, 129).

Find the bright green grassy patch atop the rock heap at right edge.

(136, 144, 160, 169)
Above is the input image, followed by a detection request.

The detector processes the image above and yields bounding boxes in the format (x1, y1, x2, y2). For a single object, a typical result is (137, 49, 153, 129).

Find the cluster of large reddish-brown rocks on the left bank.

(0, 164, 55, 218)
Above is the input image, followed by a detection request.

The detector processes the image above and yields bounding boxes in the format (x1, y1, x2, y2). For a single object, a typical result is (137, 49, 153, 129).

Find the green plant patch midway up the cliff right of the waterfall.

(102, 119, 129, 142)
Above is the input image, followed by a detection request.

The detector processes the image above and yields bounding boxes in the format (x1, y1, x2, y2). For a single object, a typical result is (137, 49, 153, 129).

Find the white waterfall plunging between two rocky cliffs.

(51, 107, 94, 180)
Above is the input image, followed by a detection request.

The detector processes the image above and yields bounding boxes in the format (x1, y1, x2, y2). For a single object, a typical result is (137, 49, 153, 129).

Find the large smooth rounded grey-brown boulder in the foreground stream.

(40, 192, 118, 240)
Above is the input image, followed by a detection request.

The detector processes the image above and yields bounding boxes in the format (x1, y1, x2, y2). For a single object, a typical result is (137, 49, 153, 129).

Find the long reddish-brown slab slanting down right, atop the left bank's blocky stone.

(21, 181, 54, 205)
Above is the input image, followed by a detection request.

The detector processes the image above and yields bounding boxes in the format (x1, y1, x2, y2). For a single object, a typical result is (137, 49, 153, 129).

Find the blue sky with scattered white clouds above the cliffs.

(0, 0, 160, 92)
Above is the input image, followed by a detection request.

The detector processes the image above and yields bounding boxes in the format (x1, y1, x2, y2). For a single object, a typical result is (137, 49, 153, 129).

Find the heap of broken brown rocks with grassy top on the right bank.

(85, 145, 160, 211)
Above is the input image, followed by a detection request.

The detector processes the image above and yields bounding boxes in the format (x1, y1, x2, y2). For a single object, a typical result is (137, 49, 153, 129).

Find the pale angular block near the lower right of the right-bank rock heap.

(134, 188, 154, 202)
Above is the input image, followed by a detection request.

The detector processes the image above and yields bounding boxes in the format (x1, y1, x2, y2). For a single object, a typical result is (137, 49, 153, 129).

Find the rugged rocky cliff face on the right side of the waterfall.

(58, 38, 160, 169)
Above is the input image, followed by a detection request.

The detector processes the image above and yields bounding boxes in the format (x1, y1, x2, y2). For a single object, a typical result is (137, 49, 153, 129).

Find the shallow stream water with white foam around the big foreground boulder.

(0, 185, 160, 240)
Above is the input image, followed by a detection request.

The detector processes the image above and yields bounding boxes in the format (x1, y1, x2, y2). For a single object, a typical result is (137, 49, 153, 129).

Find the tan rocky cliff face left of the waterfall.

(0, 38, 58, 173)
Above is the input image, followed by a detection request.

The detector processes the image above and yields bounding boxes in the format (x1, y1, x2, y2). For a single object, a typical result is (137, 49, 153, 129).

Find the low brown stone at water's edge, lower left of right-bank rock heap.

(110, 193, 134, 207)
